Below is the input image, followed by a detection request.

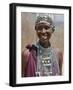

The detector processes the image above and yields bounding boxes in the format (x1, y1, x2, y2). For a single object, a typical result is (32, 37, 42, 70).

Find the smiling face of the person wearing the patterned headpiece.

(36, 22, 53, 44)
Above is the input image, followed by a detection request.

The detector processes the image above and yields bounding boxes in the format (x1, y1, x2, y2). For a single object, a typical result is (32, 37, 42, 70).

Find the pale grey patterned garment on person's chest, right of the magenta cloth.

(36, 42, 59, 76)
